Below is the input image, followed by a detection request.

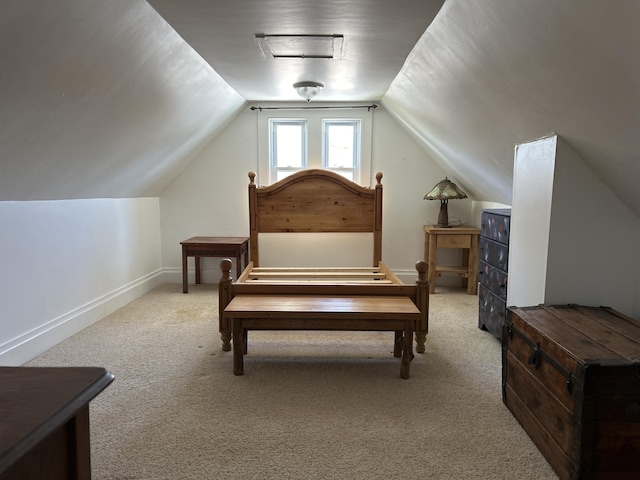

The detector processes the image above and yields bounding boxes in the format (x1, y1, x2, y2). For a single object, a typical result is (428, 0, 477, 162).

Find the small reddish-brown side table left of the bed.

(180, 237, 249, 293)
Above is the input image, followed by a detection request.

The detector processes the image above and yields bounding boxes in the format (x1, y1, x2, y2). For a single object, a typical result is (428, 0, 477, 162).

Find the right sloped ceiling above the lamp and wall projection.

(383, 0, 640, 215)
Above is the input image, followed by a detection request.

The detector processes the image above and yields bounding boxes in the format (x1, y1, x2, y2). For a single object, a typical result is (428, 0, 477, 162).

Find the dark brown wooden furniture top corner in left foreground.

(0, 367, 113, 480)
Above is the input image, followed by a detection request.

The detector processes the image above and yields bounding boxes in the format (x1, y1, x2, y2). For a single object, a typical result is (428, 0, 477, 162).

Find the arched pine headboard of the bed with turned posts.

(249, 169, 382, 266)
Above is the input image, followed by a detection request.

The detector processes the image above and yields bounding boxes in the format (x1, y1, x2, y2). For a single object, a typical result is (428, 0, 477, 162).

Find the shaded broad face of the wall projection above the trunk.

(546, 136, 640, 319)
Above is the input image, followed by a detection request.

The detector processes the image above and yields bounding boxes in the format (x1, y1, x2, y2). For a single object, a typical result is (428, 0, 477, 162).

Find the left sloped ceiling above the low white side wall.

(0, 0, 245, 200)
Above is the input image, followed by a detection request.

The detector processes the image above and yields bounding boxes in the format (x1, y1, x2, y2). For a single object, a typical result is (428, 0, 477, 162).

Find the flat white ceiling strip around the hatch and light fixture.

(149, 0, 444, 101)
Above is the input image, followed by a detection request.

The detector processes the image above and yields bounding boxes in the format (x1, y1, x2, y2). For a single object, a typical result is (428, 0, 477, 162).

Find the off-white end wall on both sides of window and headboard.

(160, 107, 471, 282)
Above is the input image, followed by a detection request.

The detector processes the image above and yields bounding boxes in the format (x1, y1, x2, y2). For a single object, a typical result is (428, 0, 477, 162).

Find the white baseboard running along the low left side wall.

(0, 269, 168, 366)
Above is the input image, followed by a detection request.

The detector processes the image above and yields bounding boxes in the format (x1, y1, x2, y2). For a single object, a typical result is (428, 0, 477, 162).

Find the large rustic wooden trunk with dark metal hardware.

(502, 305, 640, 480)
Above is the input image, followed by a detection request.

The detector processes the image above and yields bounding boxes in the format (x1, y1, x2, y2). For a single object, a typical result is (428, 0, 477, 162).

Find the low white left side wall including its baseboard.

(0, 198, 162, 365)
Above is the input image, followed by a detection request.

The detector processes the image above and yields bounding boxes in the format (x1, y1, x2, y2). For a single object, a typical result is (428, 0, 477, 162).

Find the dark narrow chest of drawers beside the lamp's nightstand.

(478, 209, 511, 338)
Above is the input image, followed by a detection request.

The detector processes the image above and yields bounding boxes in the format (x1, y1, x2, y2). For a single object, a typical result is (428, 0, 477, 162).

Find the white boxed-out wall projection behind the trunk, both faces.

(508, 134, 640, 318)
